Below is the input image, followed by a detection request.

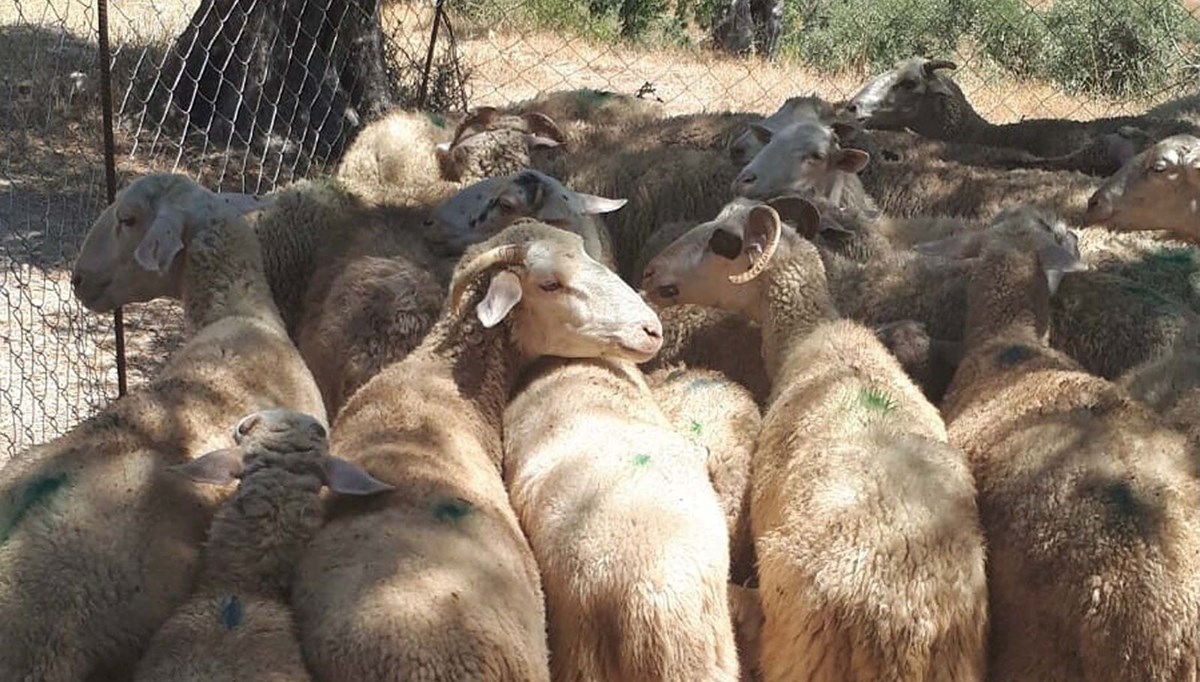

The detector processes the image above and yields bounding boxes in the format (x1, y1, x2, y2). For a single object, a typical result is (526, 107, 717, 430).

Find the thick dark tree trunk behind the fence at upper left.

(141, 0, 392, 160)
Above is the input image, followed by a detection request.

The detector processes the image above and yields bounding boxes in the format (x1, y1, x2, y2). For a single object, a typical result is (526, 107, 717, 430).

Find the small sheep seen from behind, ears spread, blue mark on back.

(133, 409, 391, 682)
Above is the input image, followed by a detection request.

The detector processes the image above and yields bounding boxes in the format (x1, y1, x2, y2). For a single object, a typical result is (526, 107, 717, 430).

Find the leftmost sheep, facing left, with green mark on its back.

(0, 174, 325, 682)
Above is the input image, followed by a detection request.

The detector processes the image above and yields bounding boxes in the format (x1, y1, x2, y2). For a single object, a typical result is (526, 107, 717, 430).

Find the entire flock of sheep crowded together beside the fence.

(0, 54, 1200, 682)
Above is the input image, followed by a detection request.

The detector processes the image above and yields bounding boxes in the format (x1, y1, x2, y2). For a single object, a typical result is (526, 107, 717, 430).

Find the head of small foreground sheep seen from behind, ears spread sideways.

(168, 409, 392, 495)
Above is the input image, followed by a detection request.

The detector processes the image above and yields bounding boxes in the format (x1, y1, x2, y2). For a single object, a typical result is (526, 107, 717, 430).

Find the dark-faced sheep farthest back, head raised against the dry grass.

(846, 58, 1196, 159)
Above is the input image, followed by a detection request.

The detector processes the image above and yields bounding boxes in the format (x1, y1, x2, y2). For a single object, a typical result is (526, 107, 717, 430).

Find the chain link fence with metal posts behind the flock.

(0, 0, 1200, 461)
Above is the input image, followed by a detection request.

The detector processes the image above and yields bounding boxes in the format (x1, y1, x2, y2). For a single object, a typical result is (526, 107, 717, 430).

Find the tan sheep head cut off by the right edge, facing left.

(1085, 134, 1200, 241)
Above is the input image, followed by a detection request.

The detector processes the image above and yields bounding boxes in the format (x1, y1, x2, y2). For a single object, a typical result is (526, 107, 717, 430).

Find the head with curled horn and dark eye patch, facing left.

(642, 196, 822, 319)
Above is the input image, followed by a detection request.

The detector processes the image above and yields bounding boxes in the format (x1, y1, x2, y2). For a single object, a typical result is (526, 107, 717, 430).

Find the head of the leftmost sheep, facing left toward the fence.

(71, 173, 271, 312)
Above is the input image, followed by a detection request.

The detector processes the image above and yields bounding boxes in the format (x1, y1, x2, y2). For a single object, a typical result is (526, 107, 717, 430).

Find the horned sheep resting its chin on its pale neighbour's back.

(293, 221, 661, 682)
